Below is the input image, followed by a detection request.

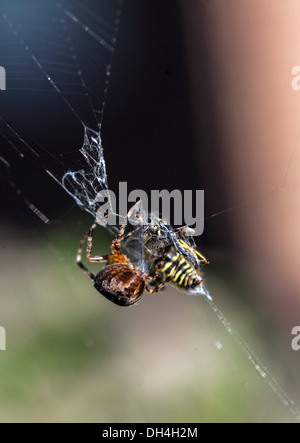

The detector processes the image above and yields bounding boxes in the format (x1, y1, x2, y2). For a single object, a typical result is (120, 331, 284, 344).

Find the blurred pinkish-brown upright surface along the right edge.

(182, 0, 300, 326)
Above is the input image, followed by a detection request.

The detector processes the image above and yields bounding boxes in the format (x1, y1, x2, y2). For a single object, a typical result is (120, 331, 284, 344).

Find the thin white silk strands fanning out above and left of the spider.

(0, 0, 123, 223)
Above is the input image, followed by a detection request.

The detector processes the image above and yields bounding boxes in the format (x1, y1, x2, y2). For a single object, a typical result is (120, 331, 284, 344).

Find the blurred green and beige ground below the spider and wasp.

(0, 223, 293, 422)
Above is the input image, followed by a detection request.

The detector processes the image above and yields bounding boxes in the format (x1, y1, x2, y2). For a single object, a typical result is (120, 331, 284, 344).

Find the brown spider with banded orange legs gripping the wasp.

(76, 201, 180, 306)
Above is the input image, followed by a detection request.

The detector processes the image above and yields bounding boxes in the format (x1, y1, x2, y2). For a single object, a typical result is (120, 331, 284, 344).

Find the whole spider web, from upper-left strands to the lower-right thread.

(0, 0, 300, 420)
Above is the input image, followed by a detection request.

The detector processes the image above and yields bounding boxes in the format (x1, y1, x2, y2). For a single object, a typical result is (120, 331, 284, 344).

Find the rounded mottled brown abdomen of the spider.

(94, 263, 146, 306)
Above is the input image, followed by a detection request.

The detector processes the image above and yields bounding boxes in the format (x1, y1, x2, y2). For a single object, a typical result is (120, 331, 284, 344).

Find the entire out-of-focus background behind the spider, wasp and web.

(0, 0, 300, 422)
